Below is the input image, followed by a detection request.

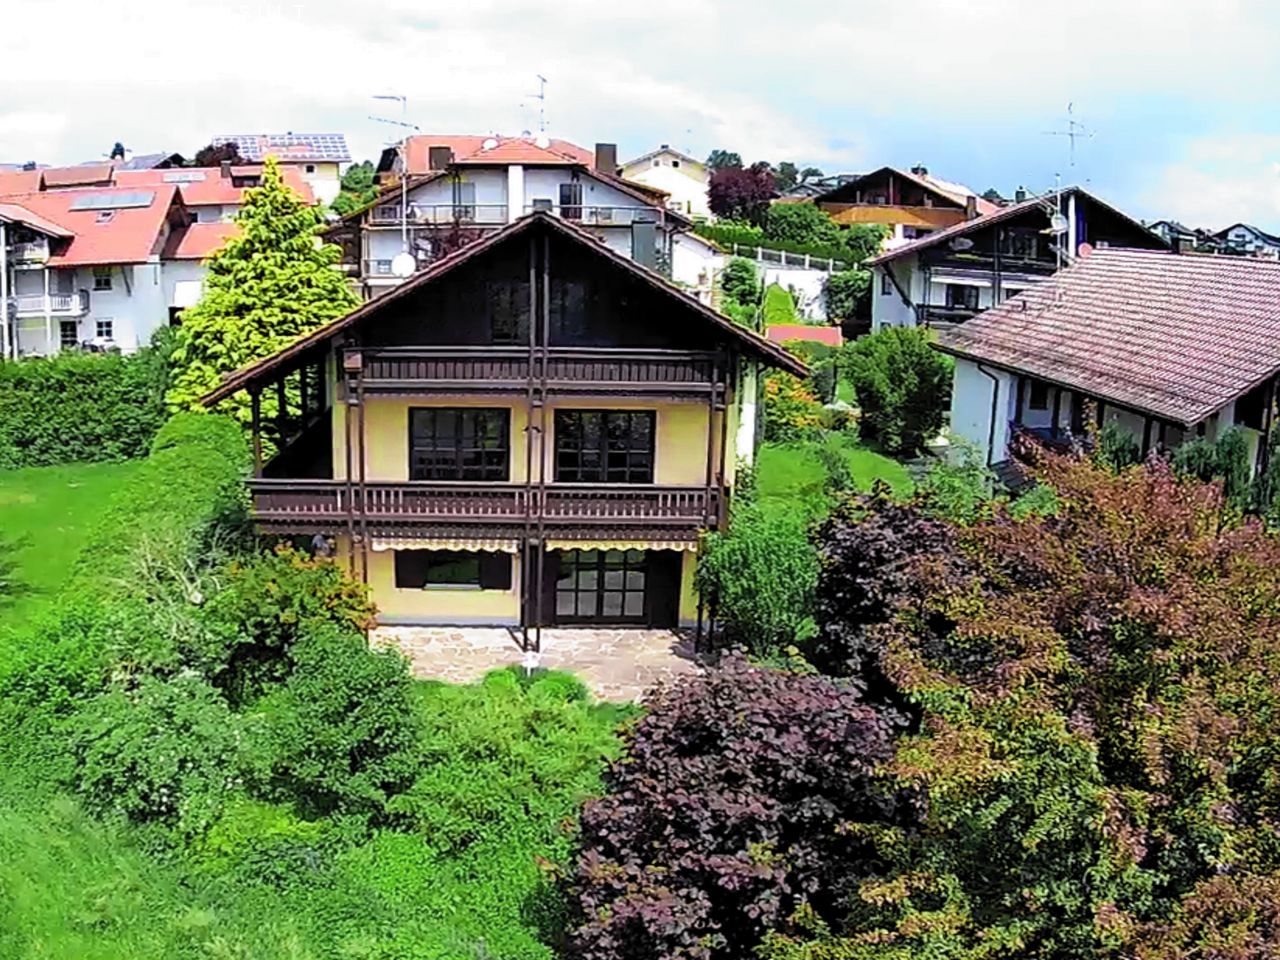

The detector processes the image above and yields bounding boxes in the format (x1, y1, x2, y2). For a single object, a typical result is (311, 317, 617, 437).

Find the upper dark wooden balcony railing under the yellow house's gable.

(362, 347, 716, 396)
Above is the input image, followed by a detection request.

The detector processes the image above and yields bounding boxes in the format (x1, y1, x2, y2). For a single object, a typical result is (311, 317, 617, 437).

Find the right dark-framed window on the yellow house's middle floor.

(556, 410, 654, 484)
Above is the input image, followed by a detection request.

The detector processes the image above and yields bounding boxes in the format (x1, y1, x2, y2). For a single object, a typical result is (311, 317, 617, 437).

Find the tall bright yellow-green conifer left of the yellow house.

(168, 157, 360, 422)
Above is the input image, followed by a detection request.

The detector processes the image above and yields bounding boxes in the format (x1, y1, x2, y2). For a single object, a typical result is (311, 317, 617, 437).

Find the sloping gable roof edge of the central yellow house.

(200, 211, 809, 407)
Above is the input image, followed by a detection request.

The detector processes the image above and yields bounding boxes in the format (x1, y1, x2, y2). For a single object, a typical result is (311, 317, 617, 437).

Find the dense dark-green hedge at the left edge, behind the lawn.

(0, 348, 169, 468)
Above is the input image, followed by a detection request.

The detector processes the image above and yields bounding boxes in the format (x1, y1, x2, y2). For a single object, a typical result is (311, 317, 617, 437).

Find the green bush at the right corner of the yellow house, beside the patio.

(696, 504, 818, 655)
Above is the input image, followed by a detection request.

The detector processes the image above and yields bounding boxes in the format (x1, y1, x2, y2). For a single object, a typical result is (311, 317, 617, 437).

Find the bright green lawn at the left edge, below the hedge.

(0, 461, 141, 626)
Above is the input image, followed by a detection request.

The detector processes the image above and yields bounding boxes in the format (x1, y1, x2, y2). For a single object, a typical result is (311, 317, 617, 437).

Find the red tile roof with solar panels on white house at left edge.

(5, 183, 178, 266)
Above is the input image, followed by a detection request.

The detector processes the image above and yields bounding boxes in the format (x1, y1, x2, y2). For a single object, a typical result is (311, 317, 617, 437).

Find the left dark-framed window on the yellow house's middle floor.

(408, 407, 511, 480)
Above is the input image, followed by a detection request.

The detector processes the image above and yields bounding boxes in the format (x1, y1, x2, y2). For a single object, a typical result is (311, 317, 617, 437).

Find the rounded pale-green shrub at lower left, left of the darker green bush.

(70, 676, 241, 833)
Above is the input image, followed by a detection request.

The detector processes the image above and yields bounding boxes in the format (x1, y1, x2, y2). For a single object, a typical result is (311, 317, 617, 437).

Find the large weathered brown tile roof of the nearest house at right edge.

(937, 248, 1280, 425)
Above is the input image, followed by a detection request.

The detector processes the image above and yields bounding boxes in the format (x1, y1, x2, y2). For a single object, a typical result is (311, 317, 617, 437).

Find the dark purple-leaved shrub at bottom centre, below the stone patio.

(568, 657, 913, 960)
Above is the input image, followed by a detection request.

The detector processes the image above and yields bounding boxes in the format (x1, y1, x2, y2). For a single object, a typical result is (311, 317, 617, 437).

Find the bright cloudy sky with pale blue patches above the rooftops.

(0, 0, 1280, 233)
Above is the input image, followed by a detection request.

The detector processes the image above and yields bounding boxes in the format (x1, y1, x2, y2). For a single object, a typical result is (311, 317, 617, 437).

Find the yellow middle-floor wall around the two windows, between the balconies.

(333, 396, 735, 486)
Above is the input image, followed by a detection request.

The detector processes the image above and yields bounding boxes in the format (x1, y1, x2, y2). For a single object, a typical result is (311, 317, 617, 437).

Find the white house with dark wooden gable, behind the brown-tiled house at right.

(865, 187, 1166, 330)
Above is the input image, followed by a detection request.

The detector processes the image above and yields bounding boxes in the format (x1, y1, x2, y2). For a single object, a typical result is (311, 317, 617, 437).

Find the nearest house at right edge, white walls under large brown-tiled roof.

(937, 248, 1280, 466)
